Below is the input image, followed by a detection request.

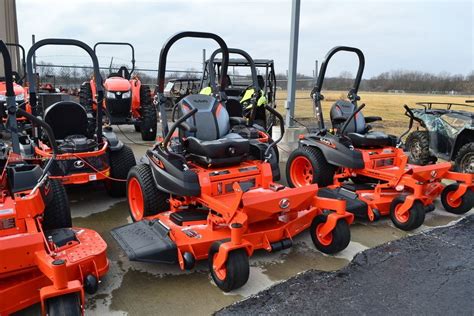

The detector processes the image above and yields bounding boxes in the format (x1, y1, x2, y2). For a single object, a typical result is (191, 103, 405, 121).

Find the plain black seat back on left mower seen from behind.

(44, 101, 88, 139)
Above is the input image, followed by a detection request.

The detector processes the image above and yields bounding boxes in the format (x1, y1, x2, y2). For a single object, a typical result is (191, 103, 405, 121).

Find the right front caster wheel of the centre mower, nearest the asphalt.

(310, 215, 351, 254)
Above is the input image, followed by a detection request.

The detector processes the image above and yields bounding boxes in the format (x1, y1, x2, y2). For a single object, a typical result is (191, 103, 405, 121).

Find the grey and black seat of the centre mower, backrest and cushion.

(179, 94, 250, 166)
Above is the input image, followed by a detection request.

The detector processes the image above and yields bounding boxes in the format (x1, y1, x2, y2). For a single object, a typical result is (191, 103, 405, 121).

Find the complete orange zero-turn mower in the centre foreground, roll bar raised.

(112, 32, 353, 292)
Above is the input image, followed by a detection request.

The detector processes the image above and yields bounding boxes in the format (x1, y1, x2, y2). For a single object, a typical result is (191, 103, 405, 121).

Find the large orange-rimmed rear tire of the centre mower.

(127, 165, 170, 222)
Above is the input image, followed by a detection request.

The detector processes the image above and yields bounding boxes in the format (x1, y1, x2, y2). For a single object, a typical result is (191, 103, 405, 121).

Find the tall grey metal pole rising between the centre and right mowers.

(285, 0, 301, 127)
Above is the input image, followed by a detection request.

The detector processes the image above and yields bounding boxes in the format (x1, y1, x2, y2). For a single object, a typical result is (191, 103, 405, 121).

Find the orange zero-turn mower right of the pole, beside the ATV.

(286, 46, 474, 230)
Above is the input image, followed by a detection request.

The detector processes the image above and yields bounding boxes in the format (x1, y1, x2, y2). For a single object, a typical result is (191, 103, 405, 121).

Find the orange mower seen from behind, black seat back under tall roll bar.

(23, 39, 136, 197)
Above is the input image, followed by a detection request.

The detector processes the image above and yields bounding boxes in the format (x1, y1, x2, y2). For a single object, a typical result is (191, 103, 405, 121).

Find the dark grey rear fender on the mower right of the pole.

(299, 138, 364, 169)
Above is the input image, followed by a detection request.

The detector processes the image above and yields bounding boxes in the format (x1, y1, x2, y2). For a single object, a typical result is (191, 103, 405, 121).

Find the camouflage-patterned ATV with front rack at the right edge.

(405, 102, 474, 173)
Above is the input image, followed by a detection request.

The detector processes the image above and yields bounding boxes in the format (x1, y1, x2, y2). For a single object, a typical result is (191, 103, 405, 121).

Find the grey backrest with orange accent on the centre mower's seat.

(178, 94, 230, 140)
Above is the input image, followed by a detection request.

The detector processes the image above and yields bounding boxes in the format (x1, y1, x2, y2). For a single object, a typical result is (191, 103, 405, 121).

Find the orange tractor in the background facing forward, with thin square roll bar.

(79, 42, 157, 141)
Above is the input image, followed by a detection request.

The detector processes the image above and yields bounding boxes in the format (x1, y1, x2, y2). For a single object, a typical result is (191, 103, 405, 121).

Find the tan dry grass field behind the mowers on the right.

(277, 90, 474, 134)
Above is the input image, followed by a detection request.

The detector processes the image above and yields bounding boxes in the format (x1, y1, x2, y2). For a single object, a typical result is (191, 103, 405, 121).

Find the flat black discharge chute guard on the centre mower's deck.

(110, 220, 178, 264)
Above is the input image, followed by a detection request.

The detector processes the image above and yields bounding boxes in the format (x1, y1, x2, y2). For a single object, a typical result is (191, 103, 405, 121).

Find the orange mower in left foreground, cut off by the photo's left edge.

(0, 41, 109, 315)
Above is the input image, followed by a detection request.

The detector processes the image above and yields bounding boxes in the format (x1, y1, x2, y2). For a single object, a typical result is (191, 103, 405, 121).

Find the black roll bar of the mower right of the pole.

(310, 46, 365, 130)
